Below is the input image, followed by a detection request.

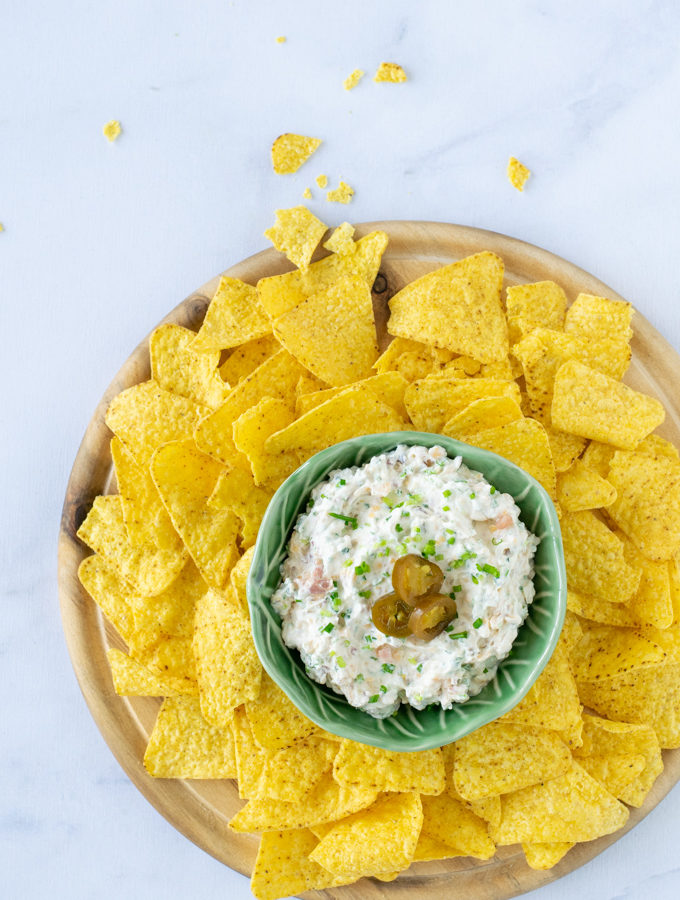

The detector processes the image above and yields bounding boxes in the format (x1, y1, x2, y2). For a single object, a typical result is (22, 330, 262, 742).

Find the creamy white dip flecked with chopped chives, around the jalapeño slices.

(272, 445, 538, 718)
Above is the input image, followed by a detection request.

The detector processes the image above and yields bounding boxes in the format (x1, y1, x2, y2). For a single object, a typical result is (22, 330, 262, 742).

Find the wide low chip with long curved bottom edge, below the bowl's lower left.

(229, 774, 378, 832)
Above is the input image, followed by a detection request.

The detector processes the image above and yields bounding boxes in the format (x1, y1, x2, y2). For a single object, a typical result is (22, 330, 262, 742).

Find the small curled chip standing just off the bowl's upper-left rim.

(233, 397, 302, 491)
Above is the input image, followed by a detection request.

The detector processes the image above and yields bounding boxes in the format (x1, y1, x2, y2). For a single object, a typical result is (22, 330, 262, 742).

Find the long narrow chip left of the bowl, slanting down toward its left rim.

(151, 441, 238, 590)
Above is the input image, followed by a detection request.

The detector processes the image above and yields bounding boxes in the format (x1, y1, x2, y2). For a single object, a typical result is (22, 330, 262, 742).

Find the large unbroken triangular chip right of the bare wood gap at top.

(387, 252, 508, 363)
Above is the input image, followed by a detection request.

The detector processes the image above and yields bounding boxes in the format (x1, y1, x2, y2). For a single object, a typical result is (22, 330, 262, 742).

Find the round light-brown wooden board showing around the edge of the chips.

(59, 221, 680, 900)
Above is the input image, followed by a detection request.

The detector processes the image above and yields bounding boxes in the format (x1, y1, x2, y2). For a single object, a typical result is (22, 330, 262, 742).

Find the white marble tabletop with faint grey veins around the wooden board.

(0, 0, 680, 900)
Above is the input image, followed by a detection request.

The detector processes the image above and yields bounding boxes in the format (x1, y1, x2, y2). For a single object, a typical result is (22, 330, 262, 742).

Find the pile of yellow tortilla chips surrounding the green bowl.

(79, 212, 680, 900)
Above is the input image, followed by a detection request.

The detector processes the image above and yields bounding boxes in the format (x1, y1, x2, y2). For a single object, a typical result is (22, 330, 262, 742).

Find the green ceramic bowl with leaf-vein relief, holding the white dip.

(247, 431, 567, 751)
